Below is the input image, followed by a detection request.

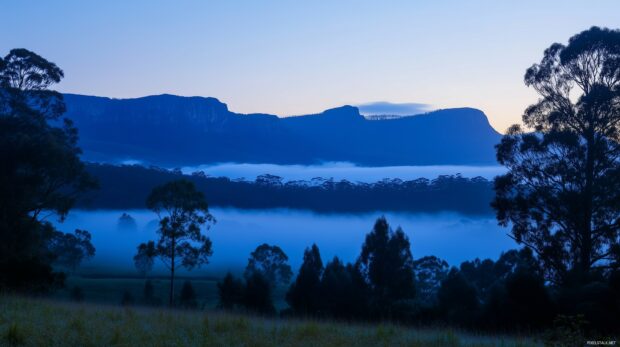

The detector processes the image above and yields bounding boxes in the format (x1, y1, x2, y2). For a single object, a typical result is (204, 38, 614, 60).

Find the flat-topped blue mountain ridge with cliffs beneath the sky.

(64, 94, 501, 166)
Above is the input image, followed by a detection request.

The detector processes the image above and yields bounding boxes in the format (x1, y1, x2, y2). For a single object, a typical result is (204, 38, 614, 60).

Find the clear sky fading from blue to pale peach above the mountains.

(0, 0, 620, 132)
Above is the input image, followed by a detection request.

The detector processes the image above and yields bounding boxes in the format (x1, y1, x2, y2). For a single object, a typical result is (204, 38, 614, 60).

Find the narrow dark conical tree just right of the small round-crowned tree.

(286, 244, 323, 315)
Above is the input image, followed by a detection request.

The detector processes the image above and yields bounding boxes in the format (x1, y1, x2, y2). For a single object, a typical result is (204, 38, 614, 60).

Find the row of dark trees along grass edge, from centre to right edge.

(209, 217, 620, 338)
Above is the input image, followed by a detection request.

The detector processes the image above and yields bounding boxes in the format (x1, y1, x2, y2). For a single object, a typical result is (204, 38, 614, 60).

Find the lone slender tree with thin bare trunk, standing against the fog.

(134, 180, 215, 305)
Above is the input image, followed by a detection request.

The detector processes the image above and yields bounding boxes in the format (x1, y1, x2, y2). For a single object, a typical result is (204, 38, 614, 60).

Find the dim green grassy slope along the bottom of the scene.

(0, 296, 537, 347)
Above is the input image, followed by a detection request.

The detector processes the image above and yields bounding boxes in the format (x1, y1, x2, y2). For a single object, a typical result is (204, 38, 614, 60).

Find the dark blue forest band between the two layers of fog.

(78, 164, 494, 214)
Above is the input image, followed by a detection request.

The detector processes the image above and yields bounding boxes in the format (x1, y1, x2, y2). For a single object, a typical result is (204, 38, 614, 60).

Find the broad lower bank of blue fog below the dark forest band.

(53, 208, 516, 276)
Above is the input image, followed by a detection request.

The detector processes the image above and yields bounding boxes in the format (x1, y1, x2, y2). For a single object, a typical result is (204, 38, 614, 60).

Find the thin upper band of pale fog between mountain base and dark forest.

(181, 162, 506, 183)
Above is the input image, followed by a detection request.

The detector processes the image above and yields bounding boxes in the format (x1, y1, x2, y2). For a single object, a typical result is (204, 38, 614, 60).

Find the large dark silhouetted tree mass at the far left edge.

(0, 49, 94, 290)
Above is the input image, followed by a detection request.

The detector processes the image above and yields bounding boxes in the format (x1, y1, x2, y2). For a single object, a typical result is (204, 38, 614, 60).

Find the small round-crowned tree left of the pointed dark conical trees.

(244, 243, 293, 287)
